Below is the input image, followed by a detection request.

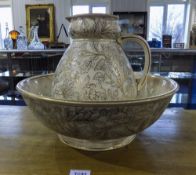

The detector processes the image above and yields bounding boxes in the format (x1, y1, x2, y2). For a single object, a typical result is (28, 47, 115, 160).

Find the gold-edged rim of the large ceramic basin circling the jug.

(16, 73, 179, 106)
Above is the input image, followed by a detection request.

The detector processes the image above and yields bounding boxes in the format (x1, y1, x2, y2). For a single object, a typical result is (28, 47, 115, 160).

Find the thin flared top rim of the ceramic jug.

(66, 13, 119, 22)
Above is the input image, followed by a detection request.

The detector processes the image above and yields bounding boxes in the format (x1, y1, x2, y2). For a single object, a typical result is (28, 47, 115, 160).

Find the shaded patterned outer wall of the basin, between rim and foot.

(25, 93, 171, 140)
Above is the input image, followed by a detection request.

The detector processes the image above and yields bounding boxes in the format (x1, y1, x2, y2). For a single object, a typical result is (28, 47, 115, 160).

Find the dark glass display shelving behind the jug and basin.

(0, 49, 196, 109)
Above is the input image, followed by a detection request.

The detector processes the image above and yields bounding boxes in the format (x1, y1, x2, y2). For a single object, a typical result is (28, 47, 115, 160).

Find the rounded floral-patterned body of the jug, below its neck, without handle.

(52, 40, 137, 101)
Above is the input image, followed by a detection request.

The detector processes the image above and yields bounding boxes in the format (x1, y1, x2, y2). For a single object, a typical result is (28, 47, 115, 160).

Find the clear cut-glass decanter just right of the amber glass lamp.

(16, 26, 27, 50)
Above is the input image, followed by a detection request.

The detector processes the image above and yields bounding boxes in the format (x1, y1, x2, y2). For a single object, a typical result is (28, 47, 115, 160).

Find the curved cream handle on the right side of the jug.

(117, 35, 151, 91)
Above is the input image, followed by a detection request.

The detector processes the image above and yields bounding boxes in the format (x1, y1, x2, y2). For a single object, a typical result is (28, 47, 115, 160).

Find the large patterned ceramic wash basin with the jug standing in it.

(17, 74, 178, 151)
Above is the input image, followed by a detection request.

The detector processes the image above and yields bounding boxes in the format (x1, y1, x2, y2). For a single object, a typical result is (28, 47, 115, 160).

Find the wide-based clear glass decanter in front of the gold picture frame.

(28, 26, 44, 50)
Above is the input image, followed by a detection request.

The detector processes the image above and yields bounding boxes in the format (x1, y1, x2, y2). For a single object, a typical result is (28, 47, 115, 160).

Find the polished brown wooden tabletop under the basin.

(0, 106, 196, 175)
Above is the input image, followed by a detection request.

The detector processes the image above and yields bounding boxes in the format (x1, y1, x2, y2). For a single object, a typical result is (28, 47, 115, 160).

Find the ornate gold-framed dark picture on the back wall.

(25, 4, 55, 43)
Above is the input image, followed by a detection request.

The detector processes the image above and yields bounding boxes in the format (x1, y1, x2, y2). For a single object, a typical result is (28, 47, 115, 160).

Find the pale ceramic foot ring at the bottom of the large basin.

(58, 134, 136, 151)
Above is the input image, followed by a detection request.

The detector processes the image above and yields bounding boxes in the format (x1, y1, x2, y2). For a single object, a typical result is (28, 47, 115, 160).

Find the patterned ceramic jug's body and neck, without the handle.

(51, 15, 149, 101)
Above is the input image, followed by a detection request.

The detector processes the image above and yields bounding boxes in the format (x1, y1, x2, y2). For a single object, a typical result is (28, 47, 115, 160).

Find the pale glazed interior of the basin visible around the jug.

(17, 74, 178, 103)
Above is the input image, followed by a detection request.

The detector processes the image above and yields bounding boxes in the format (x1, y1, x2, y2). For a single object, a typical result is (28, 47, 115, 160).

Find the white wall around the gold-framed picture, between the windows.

(12, 0, 71, 43)
